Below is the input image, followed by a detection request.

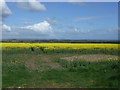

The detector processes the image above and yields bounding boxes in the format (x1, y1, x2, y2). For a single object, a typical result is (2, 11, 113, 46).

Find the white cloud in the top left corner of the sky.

(0, 0, 12, 17)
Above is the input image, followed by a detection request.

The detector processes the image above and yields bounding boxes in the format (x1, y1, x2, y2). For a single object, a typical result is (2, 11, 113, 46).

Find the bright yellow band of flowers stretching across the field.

(2, 43, 120, 50)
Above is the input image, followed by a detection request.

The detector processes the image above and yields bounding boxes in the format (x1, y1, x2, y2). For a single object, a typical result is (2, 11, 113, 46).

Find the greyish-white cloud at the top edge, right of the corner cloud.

(17, 0, 46, 11)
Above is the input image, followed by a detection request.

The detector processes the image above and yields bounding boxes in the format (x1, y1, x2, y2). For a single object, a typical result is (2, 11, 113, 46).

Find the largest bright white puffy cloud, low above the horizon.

(21, 21, 52, 34)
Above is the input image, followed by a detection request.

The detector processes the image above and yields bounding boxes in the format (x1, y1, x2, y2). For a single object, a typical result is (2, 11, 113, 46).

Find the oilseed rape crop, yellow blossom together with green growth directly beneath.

(2, 43, 119, 55)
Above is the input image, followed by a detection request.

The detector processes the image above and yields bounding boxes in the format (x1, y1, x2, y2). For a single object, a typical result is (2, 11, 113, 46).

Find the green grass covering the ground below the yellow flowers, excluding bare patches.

(2, 48, 120, 88)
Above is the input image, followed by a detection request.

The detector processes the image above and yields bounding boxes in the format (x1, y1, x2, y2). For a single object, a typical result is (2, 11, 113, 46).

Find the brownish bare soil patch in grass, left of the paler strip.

(25, 55, 63, 71)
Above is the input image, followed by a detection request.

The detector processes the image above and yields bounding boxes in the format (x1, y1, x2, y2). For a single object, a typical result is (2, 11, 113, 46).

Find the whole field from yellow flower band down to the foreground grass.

(2, 43, 120, 88)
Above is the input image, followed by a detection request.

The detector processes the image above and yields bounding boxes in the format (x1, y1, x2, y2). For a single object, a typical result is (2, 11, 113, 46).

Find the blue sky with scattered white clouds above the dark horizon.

(0, 1, 118, 40)
